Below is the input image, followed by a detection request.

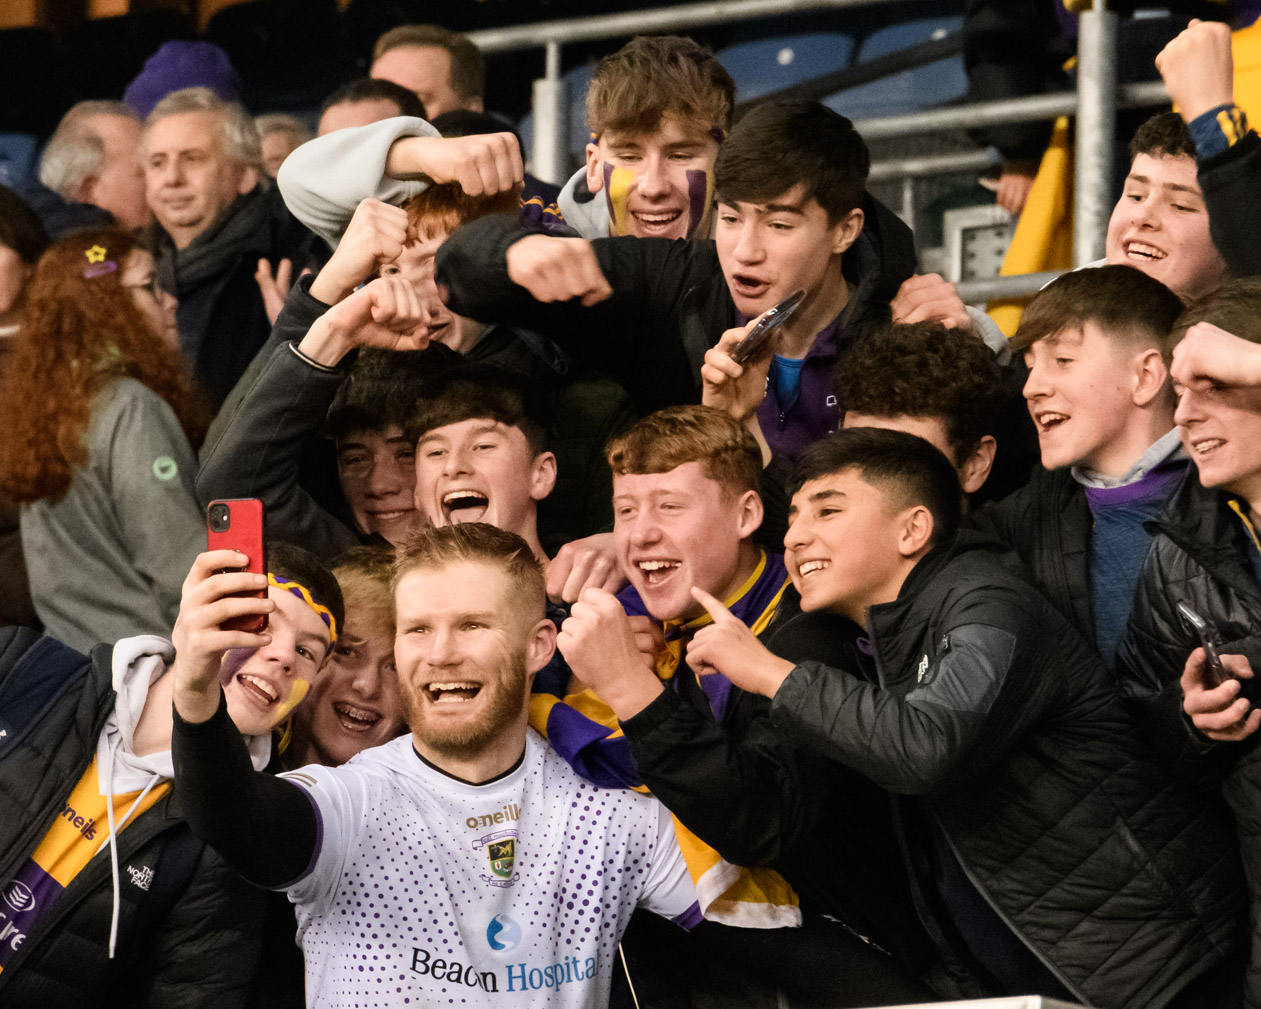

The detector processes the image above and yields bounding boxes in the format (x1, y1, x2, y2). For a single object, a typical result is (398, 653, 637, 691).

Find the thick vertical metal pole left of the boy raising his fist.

(1073, 0, 1117, 266)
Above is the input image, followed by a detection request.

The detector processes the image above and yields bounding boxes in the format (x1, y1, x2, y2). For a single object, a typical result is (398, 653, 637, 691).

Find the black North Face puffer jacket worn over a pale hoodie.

(0, 627, 262, 1009)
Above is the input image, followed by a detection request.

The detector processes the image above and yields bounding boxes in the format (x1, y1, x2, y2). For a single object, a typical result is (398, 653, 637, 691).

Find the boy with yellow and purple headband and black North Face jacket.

(0, 544, 343, 1006)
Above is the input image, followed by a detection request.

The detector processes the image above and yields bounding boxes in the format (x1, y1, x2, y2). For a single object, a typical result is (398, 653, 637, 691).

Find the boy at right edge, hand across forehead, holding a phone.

(1117, 277, 1261, 1005)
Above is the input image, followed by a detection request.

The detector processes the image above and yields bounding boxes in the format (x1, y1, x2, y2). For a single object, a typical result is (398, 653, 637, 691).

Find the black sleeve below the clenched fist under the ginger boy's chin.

(622, 690, 830, 865)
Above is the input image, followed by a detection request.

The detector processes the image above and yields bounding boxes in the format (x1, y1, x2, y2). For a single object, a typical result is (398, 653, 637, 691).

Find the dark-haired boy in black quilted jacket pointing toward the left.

(582, 430, 1243, 1009)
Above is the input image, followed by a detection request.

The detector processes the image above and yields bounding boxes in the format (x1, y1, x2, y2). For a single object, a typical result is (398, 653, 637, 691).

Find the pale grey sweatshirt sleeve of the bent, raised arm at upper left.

(276, 116, 440, 248)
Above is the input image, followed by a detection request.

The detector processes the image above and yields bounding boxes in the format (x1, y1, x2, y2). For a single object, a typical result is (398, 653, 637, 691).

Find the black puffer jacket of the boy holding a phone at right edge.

(1117, 470, 1261, 1006)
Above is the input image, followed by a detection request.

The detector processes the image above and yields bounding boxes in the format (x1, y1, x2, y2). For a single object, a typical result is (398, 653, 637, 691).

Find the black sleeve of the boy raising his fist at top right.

(1199, 131, 1261, 277)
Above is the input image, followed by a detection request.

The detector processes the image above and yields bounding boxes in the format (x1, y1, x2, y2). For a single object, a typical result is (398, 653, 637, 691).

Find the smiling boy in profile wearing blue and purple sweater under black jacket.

(975, 266, 1187, 668)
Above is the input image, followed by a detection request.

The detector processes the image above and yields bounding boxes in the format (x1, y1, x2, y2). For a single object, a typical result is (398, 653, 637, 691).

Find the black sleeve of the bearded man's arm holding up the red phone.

(170, 691, 318, 887)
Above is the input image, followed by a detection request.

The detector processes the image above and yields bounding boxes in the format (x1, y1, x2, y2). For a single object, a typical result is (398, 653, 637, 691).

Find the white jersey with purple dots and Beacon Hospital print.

(284, 730, 700, 1009)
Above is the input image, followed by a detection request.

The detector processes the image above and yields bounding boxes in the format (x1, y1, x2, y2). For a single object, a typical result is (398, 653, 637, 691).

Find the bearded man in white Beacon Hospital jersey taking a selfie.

(166, 523, 699, 1009)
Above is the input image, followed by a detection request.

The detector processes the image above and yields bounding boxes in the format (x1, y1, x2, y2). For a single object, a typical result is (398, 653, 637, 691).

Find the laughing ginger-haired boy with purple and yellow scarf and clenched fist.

(531, 406, 933, 1005)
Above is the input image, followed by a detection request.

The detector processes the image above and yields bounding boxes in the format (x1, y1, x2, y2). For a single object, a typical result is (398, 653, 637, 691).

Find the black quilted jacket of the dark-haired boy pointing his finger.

(772, 532, 1243, 1009)
